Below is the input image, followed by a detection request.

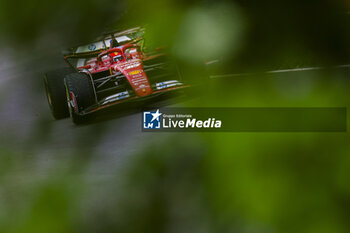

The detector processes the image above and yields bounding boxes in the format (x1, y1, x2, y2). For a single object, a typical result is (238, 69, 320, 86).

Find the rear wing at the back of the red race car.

(63, 27, 145, 59)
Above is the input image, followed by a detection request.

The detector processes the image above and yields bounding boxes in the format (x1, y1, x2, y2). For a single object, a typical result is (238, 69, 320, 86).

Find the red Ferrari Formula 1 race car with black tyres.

(44, 27, 188, 124)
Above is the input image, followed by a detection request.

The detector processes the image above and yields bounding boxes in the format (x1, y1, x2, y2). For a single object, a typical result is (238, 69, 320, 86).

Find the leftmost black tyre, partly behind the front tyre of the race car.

(44, 67, 74, 120)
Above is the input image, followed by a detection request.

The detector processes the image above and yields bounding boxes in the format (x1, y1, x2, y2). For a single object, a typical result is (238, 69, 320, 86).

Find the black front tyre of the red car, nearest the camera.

(65, 73, 96, 124)
